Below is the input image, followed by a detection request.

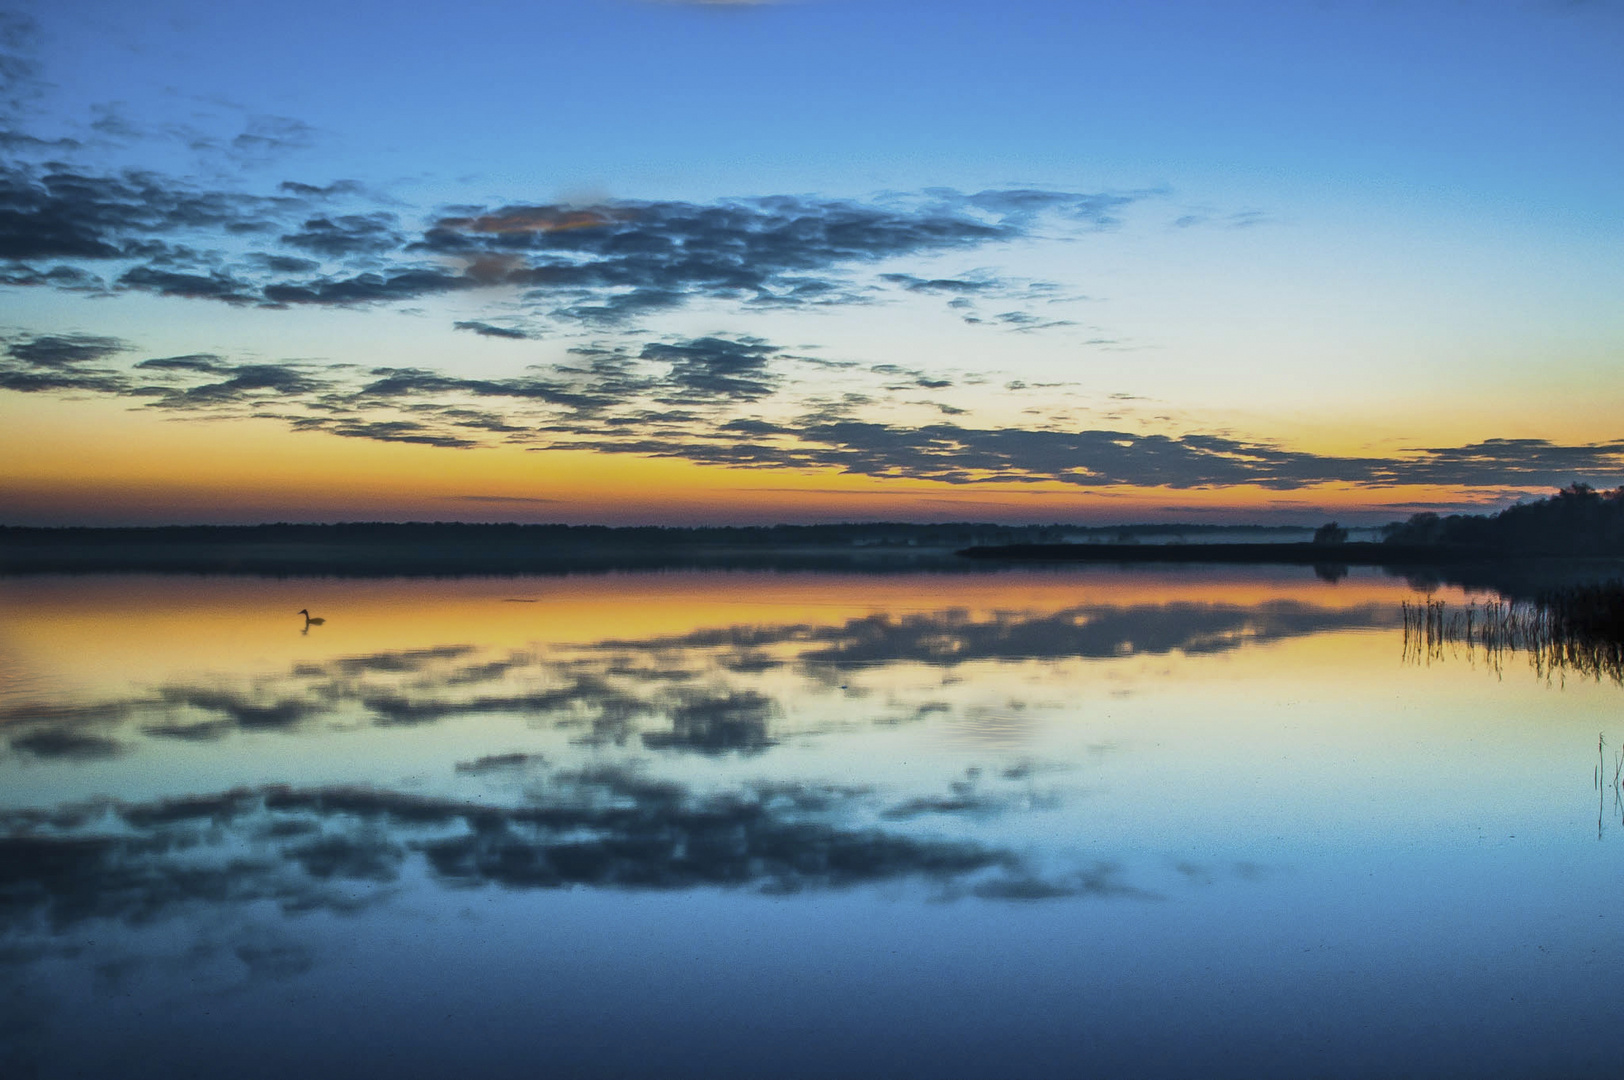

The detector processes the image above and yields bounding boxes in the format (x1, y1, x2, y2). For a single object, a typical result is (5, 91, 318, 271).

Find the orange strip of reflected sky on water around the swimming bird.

(0, 570, 1448, 685)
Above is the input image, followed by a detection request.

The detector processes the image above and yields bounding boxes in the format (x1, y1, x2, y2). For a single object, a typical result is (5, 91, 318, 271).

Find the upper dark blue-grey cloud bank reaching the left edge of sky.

(0, 156, 1137, 319)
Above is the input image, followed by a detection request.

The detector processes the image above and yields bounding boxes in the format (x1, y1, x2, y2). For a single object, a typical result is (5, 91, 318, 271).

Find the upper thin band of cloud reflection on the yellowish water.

(0, 599, 1395, 762)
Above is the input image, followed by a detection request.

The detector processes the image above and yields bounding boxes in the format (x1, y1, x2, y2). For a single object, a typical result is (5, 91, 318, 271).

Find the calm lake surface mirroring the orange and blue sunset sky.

(0, 568, 1624, 1077)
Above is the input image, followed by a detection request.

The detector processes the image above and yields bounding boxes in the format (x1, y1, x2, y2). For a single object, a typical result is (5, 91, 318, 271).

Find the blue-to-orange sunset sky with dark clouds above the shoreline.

(0, 0, 1624, 525)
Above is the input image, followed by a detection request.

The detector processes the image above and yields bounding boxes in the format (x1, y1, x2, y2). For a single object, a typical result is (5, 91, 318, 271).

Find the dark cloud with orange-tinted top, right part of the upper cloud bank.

(409, 190, 1132, 323)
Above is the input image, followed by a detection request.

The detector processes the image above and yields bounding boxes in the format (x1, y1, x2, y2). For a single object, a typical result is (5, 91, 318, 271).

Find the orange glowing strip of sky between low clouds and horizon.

(0, 395, 1520, 525)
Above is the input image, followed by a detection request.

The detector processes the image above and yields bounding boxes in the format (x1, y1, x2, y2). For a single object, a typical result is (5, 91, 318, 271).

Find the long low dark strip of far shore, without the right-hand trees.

(0, 523, 1624, 590)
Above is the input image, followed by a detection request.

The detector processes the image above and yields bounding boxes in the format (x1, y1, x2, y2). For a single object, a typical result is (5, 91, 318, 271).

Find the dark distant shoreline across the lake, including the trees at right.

(0, 484, 1624, 578)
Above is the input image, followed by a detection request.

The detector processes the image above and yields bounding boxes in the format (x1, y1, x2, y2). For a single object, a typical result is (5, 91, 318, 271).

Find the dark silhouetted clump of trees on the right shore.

(1385, 484, 1624, 555)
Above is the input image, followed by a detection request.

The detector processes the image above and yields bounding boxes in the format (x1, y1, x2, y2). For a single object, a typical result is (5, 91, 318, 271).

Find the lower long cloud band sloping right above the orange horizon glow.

(0, 321, 1624, 490)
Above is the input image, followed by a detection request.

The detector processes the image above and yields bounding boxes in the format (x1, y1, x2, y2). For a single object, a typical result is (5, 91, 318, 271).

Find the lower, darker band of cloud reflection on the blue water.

(0, 755, 1132, 939)
